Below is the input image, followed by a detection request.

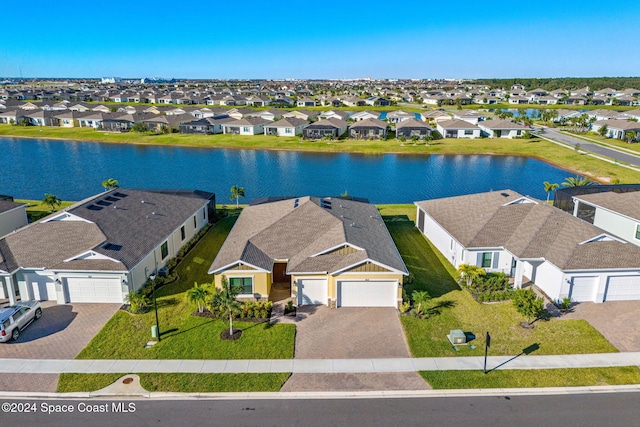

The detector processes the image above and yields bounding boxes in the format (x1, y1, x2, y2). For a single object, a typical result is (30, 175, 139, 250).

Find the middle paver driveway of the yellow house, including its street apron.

(282, 306, 429, 391)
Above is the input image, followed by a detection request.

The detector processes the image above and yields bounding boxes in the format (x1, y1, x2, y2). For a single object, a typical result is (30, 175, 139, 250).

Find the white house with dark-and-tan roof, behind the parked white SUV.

(0, 188, 215, 304)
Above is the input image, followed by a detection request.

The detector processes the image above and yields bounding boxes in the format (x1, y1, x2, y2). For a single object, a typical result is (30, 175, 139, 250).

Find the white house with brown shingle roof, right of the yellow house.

(415, 190, 640, 302)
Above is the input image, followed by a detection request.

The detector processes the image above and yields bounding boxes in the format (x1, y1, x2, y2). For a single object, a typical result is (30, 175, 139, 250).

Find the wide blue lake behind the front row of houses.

(0, 138, 573, 203)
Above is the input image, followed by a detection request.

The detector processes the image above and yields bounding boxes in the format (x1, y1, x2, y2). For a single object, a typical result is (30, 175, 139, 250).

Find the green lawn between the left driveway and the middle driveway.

(78, 216, 295, 359)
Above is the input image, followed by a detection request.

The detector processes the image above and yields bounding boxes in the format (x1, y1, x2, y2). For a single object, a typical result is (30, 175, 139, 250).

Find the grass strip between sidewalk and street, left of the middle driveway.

(57, 373, 291, 393)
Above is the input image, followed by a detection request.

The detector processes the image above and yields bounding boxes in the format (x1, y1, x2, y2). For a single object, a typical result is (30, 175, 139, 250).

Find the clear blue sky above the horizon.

(0, 0, 640, 79)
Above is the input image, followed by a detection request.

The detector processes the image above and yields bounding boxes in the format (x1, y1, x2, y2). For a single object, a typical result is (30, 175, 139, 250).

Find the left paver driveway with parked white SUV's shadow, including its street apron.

(0, 301, 120, 391)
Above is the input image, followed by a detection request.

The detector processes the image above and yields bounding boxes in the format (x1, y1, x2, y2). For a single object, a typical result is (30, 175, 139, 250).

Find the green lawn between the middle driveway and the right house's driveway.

(381, 205, 617, 357)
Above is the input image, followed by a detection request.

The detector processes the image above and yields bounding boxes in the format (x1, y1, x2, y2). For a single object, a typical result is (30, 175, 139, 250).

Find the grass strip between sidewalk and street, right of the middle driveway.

(420, 366, 640, 390)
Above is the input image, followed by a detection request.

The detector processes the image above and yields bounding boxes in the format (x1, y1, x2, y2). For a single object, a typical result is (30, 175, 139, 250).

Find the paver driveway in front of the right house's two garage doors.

(562, 301, 640, 351)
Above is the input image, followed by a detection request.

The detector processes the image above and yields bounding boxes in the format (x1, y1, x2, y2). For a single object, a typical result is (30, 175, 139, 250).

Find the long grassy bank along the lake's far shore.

(5, 125, 640, 183)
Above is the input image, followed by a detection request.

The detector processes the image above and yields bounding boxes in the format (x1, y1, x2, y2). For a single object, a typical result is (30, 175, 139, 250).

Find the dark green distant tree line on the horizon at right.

(475, 77, 640, 91)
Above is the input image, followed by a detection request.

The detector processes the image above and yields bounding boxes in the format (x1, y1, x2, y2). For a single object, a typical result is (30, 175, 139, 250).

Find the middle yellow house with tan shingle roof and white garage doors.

(209, 196, 408, 307)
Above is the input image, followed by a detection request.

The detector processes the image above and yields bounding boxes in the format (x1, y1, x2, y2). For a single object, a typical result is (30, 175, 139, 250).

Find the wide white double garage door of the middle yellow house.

(338, 280, 398, 307)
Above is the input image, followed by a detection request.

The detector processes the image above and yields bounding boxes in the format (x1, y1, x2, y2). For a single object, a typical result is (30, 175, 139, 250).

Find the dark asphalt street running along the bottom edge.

(1, 392, 640, 427)
